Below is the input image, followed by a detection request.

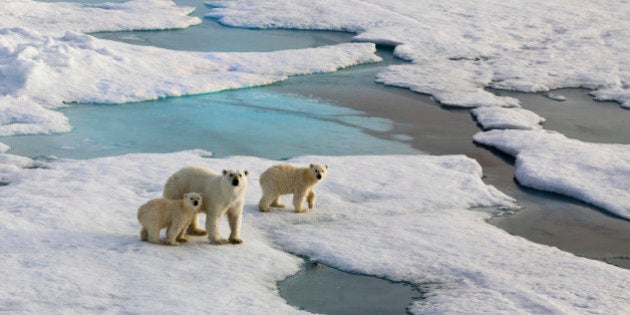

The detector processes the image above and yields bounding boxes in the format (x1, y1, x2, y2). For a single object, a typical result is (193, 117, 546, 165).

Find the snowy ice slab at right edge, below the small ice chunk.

(474, 130, 630, 219)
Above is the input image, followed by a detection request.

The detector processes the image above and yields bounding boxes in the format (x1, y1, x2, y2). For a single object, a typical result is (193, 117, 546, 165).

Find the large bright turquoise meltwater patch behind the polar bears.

(1, 89, 418, 159)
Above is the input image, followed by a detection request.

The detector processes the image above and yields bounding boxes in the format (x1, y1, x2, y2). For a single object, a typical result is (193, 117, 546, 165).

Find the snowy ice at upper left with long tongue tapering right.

(0, 0, 381, 136)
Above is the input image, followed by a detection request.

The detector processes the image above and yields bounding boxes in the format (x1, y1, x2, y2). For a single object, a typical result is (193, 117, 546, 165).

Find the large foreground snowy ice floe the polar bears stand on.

(0, 151, 630, 314)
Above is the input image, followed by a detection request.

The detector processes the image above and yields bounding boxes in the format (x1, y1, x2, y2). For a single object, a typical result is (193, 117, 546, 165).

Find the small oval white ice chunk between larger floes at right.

(470, 107, 545, 130)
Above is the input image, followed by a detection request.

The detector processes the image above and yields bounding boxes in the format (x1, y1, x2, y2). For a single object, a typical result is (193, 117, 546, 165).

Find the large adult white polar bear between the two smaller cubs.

(164, 166, 248, 244)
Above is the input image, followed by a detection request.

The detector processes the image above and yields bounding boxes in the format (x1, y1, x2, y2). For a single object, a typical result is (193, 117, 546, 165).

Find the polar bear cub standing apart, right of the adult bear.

(258, 164, 328, 212)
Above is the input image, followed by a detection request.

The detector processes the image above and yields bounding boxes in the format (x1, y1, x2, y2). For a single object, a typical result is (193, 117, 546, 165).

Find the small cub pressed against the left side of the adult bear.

(138, 192, 202, 245)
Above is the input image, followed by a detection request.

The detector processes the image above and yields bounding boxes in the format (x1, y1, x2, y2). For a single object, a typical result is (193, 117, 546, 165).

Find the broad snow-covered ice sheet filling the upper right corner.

(209, 0, 630, 107)
